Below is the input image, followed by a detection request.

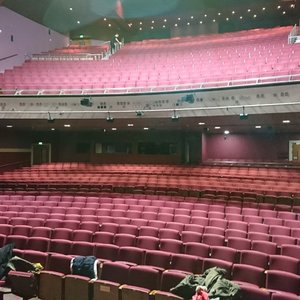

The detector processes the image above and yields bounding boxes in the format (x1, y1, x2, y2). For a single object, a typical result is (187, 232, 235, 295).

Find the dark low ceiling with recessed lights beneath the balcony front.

(0, 113, 300, 134)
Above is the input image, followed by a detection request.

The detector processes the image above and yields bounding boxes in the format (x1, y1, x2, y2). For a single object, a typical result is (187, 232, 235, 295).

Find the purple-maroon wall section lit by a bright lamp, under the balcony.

(202, 134, 300, 161)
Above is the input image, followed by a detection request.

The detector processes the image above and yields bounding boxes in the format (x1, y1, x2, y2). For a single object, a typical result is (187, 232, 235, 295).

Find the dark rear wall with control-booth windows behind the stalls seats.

(0, 130, 201, 164)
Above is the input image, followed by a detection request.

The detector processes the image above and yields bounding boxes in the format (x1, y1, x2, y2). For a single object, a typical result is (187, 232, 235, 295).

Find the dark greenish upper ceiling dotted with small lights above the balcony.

(0, 0, 300, 40)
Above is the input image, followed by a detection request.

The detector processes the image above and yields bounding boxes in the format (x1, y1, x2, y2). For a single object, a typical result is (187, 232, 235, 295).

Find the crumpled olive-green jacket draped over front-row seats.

(170, 267, 240, 300)
